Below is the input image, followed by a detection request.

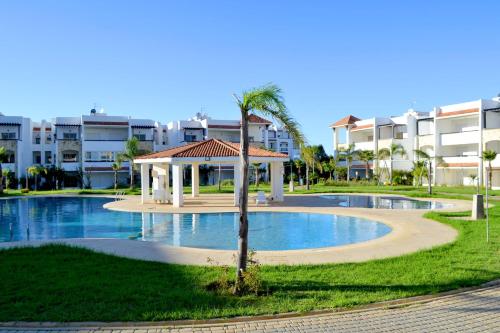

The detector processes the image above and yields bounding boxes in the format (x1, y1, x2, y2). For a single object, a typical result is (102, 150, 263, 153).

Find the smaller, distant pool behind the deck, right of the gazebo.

(321, 194, 452, 209)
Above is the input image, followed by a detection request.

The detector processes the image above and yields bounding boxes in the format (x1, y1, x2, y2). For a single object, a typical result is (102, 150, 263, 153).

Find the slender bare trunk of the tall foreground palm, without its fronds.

(234, 109, 249, 293)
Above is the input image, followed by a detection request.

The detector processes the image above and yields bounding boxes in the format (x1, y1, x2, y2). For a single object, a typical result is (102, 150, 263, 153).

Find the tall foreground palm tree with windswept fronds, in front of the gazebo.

(233, 84, 304, 294)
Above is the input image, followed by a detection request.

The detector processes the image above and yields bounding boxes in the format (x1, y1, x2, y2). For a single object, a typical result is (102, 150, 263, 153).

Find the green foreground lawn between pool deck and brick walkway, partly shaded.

(0, 198, 500, 321)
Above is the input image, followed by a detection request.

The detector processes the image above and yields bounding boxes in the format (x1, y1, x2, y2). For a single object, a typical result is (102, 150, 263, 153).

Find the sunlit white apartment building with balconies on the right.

(330, 97, 500, 187)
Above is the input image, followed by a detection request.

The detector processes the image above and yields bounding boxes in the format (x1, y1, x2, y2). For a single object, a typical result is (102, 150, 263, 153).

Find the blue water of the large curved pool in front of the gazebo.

(0, 197, 391, 250)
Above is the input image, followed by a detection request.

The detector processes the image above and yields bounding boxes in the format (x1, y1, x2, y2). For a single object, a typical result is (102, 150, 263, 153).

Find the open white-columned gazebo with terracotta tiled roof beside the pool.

(134, 139, 289, 207)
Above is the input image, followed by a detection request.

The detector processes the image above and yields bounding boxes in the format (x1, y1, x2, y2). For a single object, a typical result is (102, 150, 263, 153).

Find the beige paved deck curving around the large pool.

(0, 194, 468, 265)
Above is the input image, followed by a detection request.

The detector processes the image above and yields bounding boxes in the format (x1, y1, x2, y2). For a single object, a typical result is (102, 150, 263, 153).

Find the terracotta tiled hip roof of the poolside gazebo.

(137, 139, 288, 159)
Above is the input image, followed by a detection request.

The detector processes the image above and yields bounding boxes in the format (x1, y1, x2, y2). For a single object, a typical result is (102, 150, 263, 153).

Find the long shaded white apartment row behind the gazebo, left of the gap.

(0, 109, 300, 188)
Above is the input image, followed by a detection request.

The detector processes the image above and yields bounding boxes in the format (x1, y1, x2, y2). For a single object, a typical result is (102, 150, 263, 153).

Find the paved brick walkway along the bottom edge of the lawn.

(0, 285, 500, 333)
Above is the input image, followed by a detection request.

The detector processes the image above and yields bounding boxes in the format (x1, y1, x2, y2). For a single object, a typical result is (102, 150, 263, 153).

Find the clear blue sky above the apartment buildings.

(0, 0, 500, 152)
